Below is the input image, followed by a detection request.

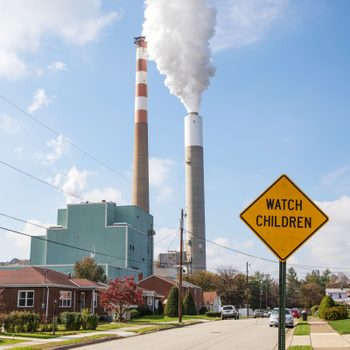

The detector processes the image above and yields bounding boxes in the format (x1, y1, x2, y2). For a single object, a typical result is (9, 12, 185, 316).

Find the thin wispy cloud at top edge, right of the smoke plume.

(211, 0, 289, 51)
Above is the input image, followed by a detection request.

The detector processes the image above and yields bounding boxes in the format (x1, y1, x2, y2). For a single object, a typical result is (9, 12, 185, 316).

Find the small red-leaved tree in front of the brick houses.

(101, 276, 143, 322)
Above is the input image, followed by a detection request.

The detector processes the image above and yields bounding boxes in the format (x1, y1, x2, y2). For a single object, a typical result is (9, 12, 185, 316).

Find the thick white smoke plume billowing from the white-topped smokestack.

(143, 0, 216, 112)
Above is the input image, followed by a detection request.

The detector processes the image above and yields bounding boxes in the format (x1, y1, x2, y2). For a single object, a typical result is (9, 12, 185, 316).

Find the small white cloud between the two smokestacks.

(149, 157, 175, 200)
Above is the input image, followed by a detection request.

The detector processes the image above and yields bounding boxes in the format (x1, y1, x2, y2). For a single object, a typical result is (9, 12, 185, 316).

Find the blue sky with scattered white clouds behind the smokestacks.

(0, 0, 350, 277)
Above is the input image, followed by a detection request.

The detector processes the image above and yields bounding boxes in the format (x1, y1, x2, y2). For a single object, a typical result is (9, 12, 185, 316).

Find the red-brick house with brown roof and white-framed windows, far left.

(0, 267, 107, 321)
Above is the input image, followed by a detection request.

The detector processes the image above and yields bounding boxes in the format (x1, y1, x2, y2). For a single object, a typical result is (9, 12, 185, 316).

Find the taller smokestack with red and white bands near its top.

(132, 36, 149, 213)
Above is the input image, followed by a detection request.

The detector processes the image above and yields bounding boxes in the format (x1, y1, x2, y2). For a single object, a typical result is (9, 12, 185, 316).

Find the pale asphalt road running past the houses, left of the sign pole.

(79, 318, 284, 350)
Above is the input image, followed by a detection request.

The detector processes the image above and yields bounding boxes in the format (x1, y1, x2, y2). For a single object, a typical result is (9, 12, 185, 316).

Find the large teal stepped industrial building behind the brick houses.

(30, 201, 154, 279)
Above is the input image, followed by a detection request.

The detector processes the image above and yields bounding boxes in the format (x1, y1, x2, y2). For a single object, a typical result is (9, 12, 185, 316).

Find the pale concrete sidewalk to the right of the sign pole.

(286, 317, 350, 350)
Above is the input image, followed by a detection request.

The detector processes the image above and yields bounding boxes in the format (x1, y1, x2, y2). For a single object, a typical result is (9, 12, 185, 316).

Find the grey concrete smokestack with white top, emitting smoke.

(185, 112, 206, 273)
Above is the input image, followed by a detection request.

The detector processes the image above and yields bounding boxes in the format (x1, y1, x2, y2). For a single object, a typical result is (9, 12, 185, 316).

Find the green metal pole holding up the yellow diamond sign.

(278, 261, 286, 350)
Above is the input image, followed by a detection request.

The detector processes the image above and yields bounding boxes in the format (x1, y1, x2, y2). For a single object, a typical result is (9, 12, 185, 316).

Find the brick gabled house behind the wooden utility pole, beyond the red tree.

(138, 275, 203, 311)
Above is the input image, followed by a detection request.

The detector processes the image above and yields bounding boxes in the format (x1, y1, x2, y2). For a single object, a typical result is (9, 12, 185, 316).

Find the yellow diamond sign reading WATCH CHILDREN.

(241, 175, 328, 261)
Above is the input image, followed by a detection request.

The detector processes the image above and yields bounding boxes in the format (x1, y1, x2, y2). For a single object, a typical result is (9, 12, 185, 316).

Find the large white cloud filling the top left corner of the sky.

(0, 0, 119, 79)
